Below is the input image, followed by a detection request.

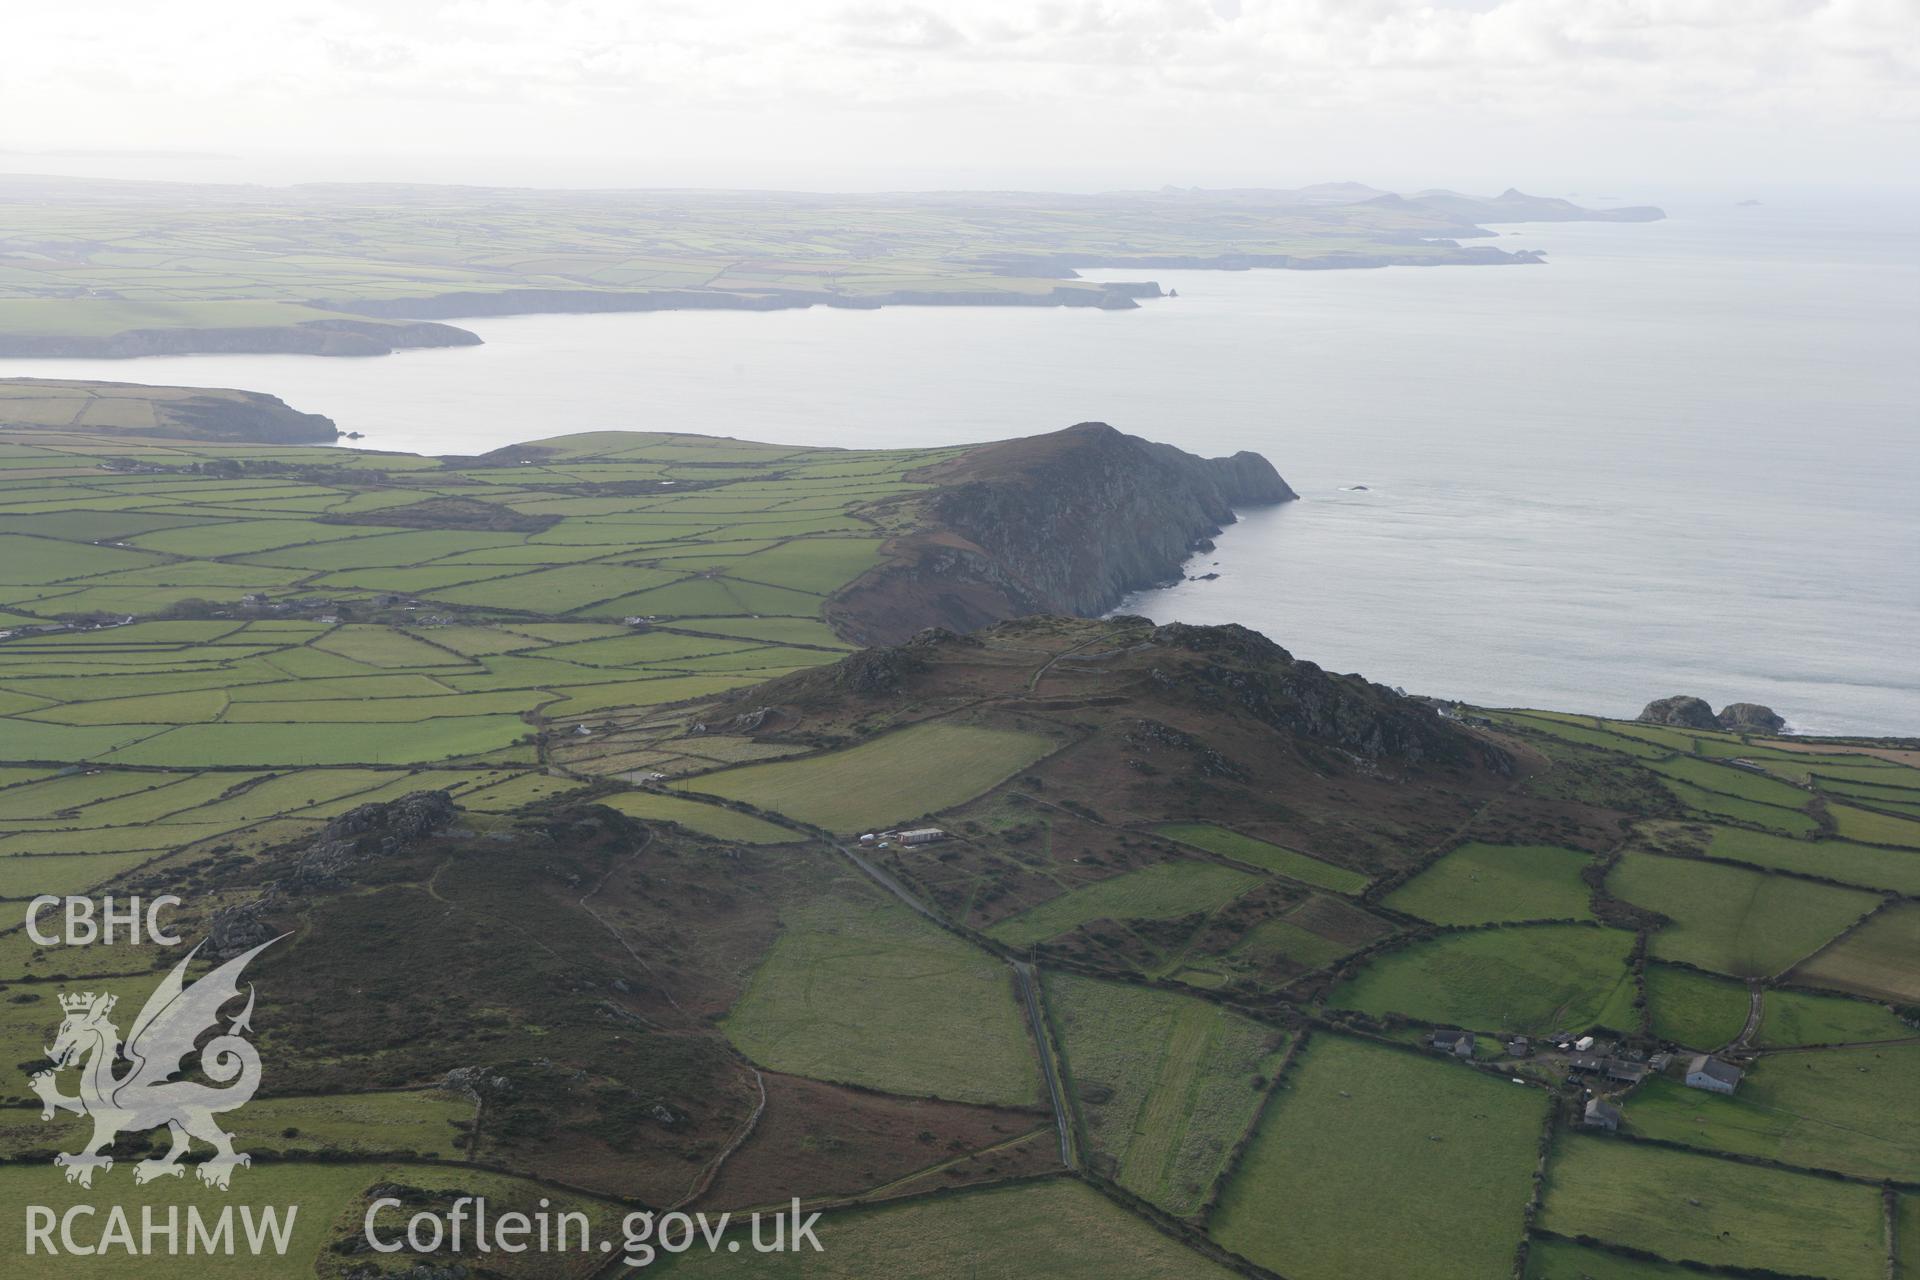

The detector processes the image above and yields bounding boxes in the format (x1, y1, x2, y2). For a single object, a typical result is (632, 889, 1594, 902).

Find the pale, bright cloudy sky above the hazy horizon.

(0, 0, 1920, 196)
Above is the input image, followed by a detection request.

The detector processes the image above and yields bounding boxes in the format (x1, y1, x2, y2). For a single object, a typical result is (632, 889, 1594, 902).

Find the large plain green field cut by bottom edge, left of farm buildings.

(1210, 1036, 1546, 1280)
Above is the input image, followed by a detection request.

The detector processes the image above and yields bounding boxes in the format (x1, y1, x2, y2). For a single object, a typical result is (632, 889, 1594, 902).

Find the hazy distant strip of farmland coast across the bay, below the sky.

(0, 177, 1665, 359)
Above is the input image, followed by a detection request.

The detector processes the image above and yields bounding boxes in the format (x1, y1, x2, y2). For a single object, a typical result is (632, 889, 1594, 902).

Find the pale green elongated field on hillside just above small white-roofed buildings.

(682, 722, 1056, 831)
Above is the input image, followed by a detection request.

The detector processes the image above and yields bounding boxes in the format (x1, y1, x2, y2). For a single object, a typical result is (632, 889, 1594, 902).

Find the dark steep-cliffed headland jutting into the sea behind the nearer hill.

(829, 422, 1296, 645)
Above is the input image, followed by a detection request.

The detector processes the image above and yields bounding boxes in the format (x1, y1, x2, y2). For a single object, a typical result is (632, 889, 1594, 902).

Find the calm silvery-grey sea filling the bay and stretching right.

(0, 201, 1920, 735)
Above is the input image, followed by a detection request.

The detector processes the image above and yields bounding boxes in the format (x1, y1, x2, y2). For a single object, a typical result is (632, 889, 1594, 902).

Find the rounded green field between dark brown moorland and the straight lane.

(724, 881, 1041, 1107)
